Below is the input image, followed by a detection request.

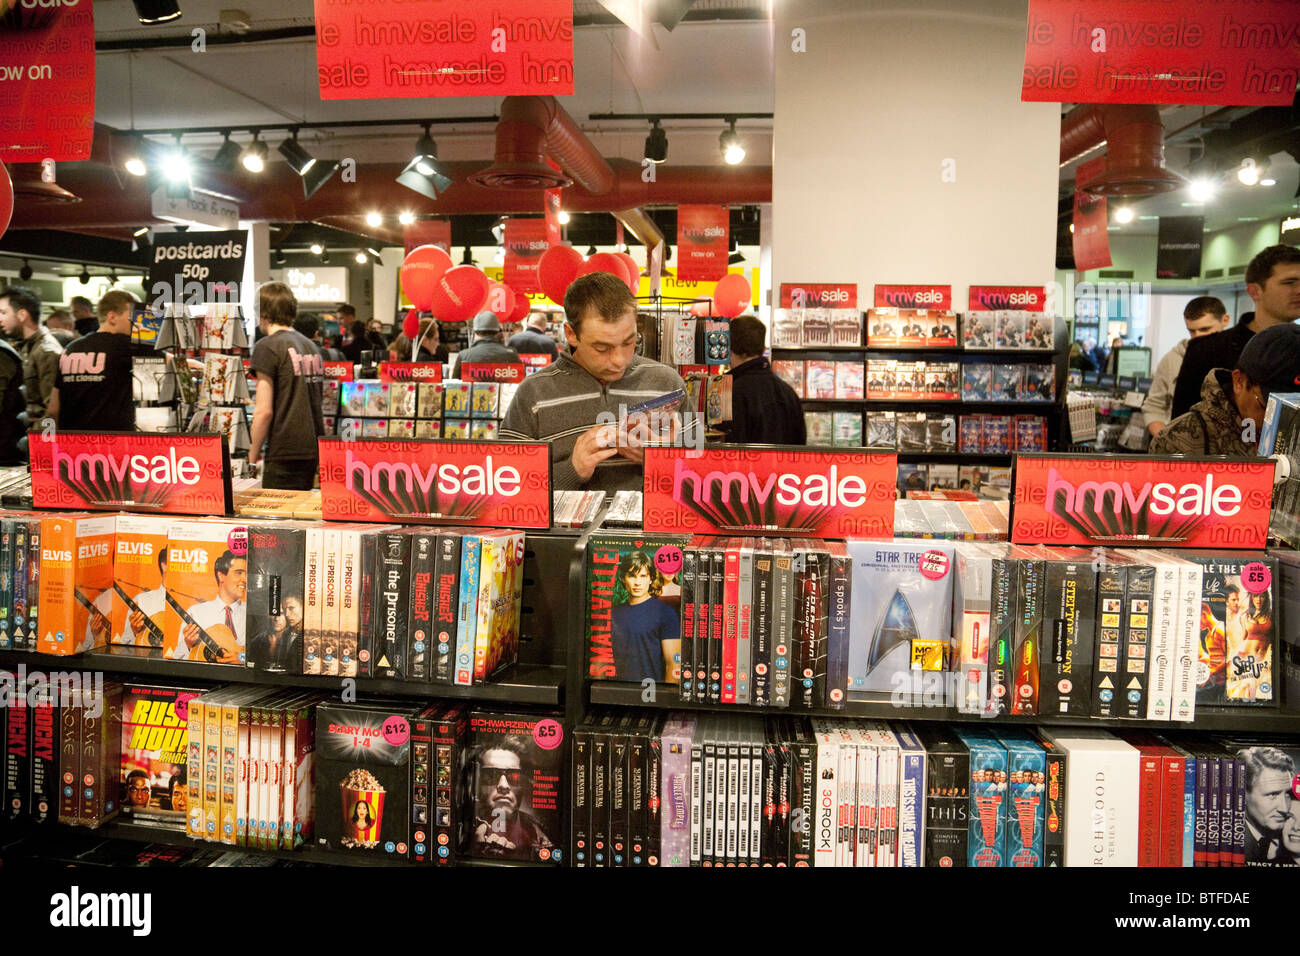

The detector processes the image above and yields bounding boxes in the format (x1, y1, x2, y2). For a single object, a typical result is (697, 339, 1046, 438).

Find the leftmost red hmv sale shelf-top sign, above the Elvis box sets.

(30, 432, 231, 515)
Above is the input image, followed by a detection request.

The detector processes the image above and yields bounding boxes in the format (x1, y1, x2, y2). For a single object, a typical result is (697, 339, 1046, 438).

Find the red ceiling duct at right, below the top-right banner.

(1061, 103, 1183, 196)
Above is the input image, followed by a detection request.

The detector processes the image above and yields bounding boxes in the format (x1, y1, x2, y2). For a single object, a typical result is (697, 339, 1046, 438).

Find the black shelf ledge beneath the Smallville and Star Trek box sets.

(588, 680, 1300, 734)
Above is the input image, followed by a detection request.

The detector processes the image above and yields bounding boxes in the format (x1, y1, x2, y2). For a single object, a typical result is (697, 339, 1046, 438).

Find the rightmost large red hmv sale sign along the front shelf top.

(1011, 455, 1273, 548)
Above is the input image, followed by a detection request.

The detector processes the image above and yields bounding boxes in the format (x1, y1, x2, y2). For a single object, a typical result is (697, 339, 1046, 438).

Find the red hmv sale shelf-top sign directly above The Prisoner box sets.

(320, 438, 551, 528)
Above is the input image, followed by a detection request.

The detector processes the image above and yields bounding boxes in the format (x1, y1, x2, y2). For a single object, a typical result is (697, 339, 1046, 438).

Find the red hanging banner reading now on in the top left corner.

(0, 0, 95, 163)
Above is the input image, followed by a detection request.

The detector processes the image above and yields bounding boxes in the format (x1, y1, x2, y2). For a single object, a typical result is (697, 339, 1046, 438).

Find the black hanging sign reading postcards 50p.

(146, 229, 248, 308)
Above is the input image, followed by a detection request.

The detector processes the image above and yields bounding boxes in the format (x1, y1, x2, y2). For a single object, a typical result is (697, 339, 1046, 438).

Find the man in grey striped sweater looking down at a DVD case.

(498, 272, 698, 492)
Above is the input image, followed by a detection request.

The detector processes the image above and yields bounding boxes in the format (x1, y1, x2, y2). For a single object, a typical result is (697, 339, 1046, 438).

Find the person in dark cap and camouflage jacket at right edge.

(1151, 323, 1300, 458)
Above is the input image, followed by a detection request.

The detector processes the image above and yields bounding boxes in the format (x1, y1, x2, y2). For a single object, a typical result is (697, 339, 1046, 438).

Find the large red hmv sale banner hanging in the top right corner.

(1021, 0, 1300, 107)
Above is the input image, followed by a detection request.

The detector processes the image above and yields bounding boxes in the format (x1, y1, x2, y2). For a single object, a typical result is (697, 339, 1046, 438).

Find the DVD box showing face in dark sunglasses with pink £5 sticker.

(460, 710, 566, 864)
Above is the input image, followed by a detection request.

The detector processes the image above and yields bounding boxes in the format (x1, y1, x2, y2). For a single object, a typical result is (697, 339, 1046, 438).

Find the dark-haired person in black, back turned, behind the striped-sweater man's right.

(722, 315, 807, 445)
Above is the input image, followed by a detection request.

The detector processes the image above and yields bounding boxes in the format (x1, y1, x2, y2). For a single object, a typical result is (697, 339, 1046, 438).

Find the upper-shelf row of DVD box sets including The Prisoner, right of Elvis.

(248, 523, 524, 685)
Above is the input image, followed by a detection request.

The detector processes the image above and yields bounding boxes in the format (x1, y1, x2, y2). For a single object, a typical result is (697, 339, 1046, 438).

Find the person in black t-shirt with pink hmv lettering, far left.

(46, 290, 135, 432)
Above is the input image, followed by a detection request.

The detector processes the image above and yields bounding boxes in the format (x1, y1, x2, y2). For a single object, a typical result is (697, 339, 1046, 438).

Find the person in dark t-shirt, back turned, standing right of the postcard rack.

(248, 282, 325, 490)
